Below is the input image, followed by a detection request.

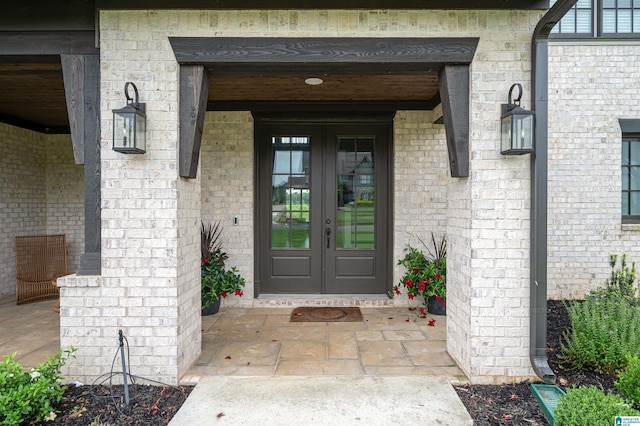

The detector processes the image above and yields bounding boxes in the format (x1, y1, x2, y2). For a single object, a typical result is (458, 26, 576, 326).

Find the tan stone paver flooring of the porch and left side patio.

(0, 297, 467, 384)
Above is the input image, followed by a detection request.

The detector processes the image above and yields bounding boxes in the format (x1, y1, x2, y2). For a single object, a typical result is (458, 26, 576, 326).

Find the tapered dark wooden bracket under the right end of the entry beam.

(438, 64, 469, 177)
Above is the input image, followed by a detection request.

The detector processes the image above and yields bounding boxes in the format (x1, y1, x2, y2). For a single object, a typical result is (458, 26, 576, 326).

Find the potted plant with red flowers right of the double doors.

(394, 232, 447, 315)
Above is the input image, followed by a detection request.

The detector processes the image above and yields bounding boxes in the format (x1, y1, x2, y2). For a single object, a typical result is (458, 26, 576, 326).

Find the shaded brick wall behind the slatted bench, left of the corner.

(0, 123, 47, 296)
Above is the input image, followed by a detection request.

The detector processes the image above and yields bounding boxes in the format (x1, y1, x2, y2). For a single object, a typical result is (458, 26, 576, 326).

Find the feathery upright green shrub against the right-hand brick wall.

(561, 296, 640, 374)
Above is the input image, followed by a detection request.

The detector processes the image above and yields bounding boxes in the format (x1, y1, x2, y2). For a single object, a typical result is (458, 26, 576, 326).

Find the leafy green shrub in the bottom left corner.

(0, 348, 75, 425)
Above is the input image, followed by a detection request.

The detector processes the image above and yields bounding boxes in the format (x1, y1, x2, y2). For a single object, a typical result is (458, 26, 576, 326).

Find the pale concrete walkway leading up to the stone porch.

(169, 376, 473, 426)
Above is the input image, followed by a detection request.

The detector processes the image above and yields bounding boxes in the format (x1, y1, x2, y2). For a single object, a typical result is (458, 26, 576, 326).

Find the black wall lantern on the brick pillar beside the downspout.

(500, 83, 535, 155)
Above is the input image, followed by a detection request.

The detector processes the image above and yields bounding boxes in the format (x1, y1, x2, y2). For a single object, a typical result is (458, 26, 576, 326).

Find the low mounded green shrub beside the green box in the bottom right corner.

(554, 386, 640, 426)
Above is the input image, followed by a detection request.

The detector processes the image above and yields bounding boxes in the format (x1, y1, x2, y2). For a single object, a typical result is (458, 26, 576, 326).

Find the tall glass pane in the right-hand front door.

(336, 137, 375, 249)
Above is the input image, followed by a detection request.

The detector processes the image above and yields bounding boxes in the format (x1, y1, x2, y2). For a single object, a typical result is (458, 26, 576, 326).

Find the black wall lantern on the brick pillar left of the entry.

(113, 82, 147, 154)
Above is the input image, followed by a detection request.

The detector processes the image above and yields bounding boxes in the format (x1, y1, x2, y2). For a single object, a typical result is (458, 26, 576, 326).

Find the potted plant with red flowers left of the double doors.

(200, 222, 245, 315)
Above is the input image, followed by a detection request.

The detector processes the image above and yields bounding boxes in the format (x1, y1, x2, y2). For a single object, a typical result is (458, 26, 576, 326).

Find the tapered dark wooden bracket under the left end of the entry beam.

(180, 65, 209, 179)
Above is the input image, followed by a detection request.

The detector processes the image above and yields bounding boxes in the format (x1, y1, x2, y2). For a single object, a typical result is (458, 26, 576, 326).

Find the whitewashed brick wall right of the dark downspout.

(548, 42, 640, 298)
